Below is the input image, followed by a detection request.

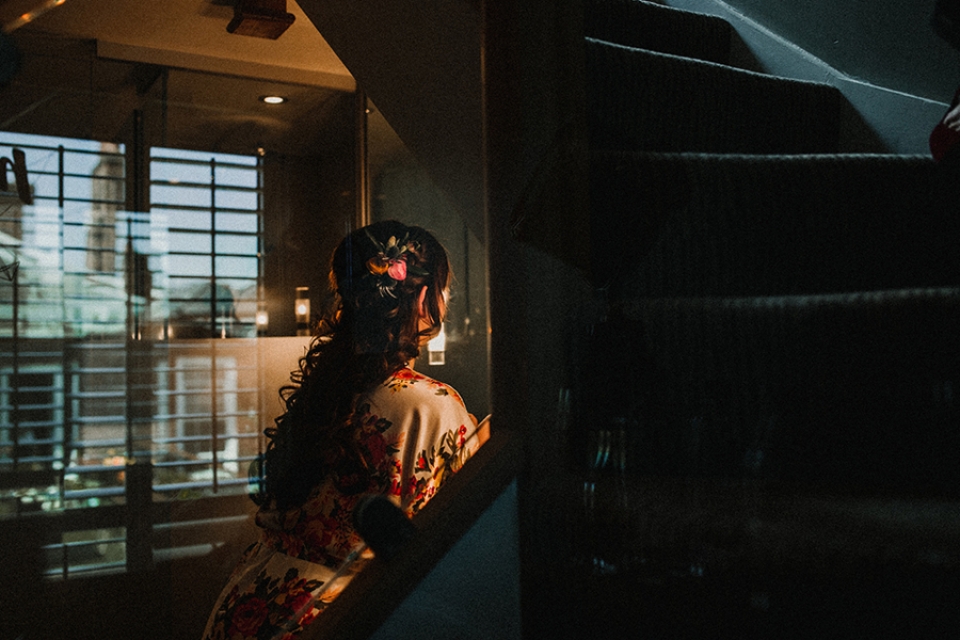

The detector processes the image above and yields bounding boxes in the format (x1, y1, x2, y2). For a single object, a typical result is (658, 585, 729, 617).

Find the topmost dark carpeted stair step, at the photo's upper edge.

(584, 0, 735, 65)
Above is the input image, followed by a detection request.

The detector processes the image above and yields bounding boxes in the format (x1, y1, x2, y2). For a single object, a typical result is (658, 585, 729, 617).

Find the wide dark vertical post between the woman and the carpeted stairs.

(480, 0, 593, 637)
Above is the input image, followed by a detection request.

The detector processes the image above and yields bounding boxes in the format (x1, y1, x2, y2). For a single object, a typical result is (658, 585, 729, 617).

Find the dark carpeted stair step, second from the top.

(586, 38, 843, 154)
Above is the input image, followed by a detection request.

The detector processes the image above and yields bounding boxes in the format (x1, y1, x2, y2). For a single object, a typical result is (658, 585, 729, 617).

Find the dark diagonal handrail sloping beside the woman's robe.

(301, 429, 523, 640)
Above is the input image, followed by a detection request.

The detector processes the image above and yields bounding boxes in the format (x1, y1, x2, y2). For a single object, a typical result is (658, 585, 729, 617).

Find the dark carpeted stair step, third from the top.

(591, 152, 960, 298)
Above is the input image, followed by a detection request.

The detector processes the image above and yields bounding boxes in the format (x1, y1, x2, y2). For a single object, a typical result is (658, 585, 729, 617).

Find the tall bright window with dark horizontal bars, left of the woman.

(0, 133, 263, 577)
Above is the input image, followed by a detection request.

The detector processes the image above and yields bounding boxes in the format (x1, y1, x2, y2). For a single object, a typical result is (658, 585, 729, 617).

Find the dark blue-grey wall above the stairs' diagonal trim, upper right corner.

(725, 0, 960, 102)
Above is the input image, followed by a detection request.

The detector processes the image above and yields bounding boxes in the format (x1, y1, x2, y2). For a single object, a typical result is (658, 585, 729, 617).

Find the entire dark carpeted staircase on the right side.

(567, 0, 960, 638)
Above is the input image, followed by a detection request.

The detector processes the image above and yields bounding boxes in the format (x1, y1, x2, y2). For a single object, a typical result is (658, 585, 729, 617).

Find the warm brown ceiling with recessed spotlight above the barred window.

(0, 0, 374, 154)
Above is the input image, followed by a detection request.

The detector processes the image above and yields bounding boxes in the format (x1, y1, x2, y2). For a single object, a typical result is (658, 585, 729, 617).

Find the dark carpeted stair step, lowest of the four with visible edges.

(581, 288, 960, 495)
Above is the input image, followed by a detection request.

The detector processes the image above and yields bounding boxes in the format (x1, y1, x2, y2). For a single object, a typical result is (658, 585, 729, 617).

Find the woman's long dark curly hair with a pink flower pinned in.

(257, 221, 450, 509)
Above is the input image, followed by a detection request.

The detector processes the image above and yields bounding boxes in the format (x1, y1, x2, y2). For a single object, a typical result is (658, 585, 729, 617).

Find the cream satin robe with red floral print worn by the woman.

(203, 368, 478, 640)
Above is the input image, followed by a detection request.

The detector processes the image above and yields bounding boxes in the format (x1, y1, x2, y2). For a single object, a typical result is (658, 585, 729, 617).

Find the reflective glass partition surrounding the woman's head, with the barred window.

(0, 34, 489, 597)
